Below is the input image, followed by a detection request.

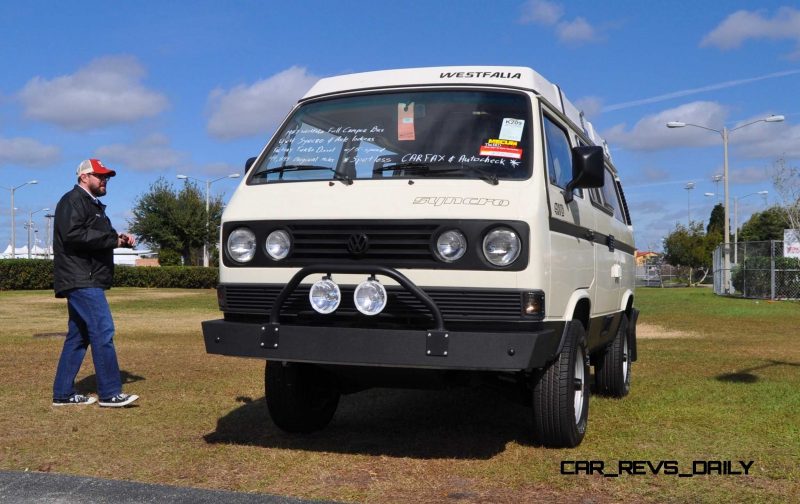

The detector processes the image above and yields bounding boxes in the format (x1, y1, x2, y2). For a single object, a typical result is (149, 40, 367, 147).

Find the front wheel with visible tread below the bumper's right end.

(533, 320, 589, 448)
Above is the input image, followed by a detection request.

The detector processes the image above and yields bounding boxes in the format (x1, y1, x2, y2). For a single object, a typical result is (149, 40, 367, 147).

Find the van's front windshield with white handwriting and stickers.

(249, 91, 532, 184)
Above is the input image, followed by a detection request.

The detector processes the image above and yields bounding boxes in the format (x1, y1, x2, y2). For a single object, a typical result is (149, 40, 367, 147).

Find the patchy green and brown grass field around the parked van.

(0, 288, 800, 503)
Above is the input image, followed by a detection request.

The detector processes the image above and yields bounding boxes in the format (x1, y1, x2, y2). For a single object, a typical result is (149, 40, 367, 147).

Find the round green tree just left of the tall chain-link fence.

(664, 222, 719, 286)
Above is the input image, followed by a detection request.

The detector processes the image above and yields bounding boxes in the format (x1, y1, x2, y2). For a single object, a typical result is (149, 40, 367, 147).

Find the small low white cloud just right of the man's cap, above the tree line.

(96, 134, 183, 172)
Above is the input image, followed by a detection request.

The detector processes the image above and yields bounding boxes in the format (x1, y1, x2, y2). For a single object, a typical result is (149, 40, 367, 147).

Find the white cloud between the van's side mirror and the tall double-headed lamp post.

(601, 101, 727, 151)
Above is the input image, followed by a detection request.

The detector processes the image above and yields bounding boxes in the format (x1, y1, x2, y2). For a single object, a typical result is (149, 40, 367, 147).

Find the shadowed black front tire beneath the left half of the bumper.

(264, 362, 340, 433)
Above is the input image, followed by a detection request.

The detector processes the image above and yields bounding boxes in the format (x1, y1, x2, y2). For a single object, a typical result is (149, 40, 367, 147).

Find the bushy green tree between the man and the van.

(128, 177, 222, 265)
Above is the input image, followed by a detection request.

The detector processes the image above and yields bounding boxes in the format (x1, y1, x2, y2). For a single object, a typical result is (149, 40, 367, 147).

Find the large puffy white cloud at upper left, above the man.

(18, 56, 167, 130)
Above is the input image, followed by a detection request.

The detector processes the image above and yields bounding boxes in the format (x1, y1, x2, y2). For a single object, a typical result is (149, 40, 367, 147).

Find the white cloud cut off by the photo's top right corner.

(700, 7, 800, 59)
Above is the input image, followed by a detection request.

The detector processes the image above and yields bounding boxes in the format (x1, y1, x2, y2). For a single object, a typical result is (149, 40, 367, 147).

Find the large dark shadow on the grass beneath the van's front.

(205, 388, 530, 459)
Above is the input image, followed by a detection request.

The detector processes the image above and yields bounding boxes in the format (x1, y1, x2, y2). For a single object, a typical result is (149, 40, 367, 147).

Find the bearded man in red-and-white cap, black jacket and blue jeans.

(53, 159, 139, 407)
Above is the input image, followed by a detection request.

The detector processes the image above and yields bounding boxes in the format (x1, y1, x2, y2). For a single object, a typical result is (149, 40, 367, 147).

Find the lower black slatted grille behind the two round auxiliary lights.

(220, 285, 523, 322)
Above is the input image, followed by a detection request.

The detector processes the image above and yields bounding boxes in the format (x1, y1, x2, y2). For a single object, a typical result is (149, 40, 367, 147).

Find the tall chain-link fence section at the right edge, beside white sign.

(714, 240, 800, 299)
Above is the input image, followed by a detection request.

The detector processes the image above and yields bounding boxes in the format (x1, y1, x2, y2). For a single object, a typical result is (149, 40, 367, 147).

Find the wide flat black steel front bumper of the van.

(203, 320, 561, 371)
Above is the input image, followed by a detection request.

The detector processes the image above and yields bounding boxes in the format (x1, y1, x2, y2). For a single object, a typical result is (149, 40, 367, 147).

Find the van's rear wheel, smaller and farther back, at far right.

(594, 313, 631, 397)
